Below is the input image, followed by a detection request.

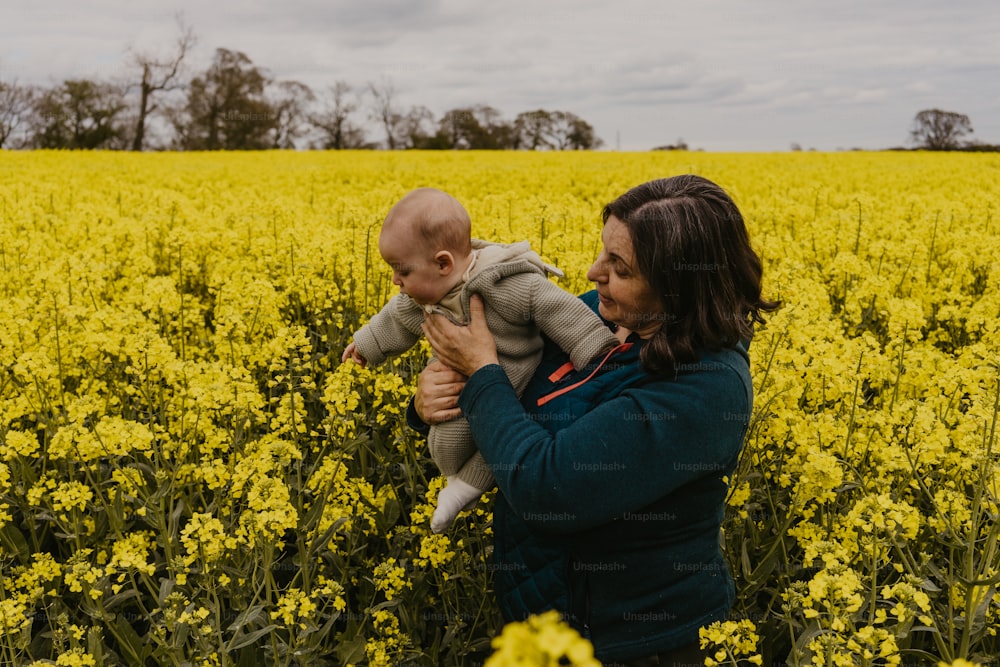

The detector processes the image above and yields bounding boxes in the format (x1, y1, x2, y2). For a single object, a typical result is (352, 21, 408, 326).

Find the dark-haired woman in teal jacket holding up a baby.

(416, 175, 778, 665)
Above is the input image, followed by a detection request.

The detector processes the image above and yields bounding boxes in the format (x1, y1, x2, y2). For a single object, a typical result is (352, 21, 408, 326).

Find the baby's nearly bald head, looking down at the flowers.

(378, 188, 472, 305)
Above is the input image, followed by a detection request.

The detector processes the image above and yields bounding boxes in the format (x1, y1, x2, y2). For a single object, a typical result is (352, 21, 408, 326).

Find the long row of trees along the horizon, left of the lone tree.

(0, 28, 603, 151)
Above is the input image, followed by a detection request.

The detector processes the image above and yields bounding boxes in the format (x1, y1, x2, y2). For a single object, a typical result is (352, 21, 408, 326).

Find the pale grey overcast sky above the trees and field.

(0, 0, 1000, 151)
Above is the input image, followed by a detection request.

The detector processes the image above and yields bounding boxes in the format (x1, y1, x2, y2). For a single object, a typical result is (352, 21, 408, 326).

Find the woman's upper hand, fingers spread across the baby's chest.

(423, 294, 498, 377)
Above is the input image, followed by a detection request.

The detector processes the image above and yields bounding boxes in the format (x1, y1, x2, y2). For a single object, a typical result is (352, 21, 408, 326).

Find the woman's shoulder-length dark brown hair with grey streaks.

(603, 174, 780, 375)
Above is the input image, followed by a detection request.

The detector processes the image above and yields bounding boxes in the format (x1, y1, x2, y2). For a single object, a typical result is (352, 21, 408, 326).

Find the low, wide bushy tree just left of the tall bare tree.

(29, 79, 127, 149)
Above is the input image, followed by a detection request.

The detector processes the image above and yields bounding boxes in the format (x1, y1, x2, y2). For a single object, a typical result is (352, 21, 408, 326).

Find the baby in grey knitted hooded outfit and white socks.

(341, 188, 618, 533)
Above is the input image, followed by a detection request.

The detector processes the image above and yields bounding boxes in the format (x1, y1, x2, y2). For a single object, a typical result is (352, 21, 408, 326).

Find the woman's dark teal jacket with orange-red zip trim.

(459, 293, 753, 661)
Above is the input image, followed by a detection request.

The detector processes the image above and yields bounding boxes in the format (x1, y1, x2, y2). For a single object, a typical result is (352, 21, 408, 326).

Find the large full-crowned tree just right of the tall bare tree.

(172, 49, 277, 150)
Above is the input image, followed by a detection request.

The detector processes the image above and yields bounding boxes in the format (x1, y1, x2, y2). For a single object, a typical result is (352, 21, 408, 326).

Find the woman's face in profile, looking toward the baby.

(587, 216, 665, 338)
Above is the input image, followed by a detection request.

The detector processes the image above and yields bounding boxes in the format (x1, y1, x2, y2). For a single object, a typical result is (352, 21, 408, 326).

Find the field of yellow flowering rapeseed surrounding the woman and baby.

(0, 152, 1000, 666)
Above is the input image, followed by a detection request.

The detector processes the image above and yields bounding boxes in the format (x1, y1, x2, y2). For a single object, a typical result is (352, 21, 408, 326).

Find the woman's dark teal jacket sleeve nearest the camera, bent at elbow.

(459, 358, 752, 533)
